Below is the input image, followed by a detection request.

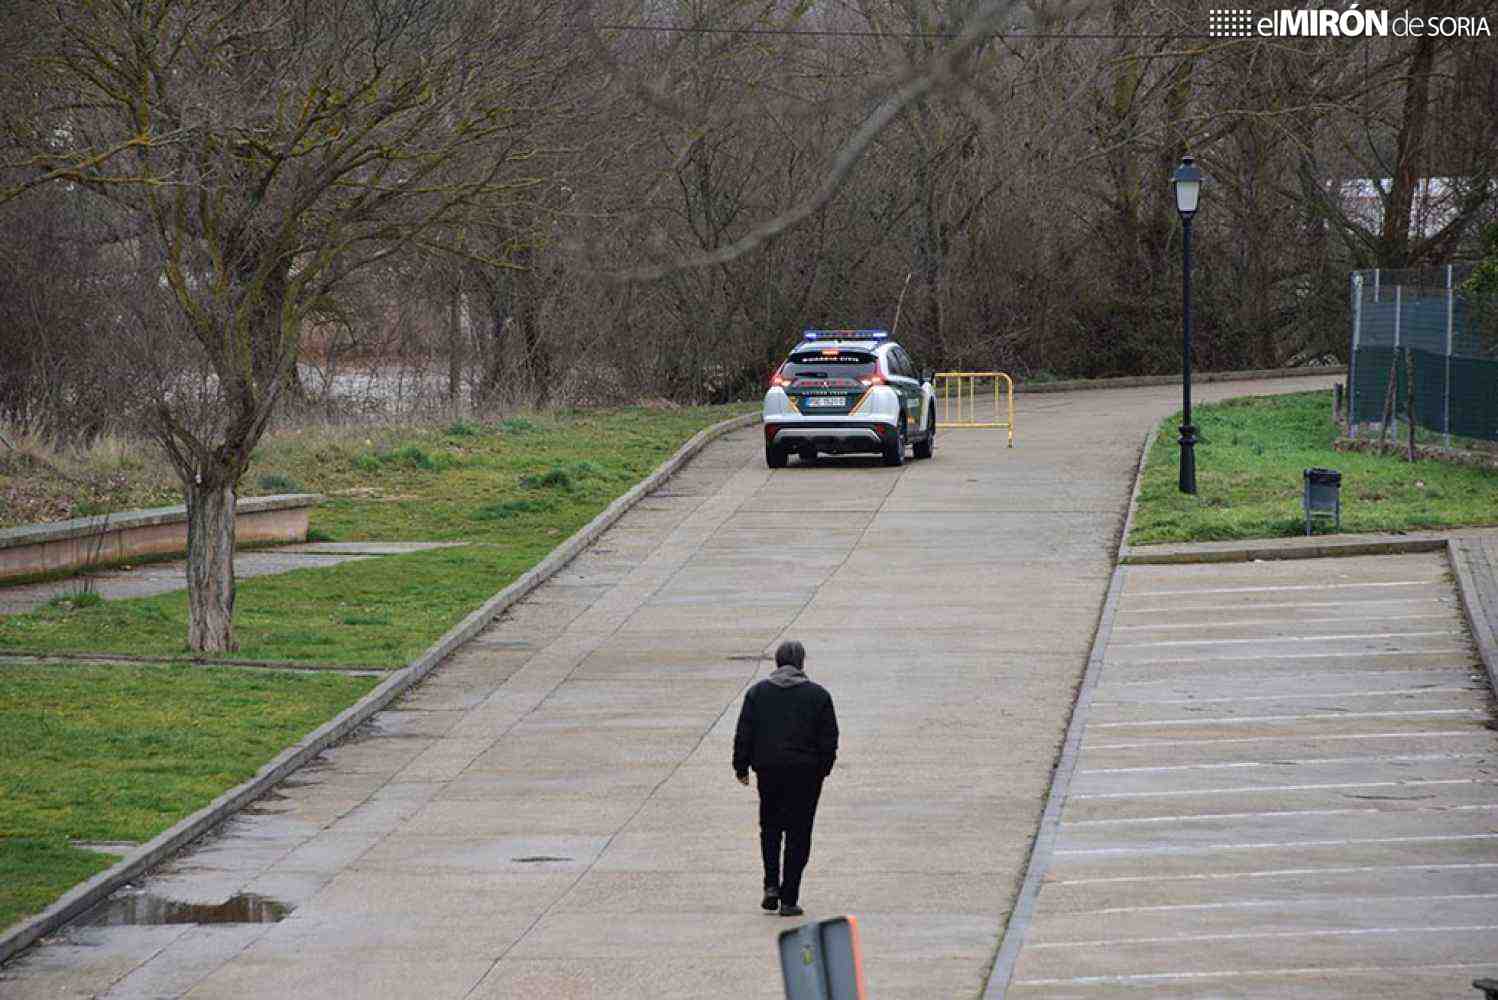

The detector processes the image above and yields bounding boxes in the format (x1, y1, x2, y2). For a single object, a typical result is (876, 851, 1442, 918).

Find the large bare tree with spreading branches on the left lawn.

(0, 0, 566, 651)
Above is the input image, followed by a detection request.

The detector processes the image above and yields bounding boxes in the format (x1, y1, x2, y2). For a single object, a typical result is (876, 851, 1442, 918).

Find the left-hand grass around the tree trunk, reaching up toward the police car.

(0, 406, 746, 668)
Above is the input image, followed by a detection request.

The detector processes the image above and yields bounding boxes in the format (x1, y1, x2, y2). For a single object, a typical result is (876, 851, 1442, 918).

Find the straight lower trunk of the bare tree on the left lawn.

(187, 484, 238, 653)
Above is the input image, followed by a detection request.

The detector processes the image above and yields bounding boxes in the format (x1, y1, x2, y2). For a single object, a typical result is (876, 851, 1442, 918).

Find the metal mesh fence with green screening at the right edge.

(1347, 265, 1498, 443)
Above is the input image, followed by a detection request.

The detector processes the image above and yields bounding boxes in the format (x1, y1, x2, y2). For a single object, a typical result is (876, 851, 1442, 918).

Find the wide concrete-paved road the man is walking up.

(0, 380, 1330, 1000)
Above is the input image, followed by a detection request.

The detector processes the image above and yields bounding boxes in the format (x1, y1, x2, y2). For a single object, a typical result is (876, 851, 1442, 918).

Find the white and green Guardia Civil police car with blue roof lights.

(764, 329, 936, 469)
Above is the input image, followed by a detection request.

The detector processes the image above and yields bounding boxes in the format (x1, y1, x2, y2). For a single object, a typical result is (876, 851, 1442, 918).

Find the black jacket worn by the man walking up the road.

(734, 680, 837, 777)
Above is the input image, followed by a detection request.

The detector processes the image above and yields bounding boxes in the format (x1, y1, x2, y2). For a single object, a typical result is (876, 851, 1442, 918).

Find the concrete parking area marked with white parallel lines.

(1007, 552, 1498, 1000)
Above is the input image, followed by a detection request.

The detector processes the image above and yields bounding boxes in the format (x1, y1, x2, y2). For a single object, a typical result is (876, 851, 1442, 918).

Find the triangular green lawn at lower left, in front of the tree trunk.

(0, 665, 377, 927)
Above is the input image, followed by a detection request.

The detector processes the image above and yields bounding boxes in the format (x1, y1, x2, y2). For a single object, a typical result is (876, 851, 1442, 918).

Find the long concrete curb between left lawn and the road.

(0, 413, 759, 963)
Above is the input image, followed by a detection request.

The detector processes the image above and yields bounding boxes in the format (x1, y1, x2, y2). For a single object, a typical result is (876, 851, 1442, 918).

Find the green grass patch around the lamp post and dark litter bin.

(1128, 392, 1498, 545)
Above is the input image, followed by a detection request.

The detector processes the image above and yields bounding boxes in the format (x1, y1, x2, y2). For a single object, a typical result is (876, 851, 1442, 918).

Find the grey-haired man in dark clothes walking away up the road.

(734, 641, 837, 916)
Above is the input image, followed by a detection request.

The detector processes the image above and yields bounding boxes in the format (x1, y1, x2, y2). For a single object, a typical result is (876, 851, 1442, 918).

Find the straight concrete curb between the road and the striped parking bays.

(983, 566, 1125, 1000)
